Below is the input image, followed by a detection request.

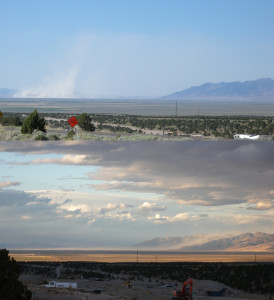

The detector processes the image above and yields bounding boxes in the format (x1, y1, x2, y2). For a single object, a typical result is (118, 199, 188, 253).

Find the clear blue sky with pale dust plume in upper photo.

(0, 0, 274, 98)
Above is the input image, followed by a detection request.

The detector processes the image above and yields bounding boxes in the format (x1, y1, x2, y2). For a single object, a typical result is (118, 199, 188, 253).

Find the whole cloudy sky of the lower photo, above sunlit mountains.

(0, 141, 274, 249)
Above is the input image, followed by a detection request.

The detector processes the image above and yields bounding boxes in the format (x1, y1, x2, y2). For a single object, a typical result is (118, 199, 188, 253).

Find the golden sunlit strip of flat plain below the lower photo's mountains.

(10, 251, 274, 263)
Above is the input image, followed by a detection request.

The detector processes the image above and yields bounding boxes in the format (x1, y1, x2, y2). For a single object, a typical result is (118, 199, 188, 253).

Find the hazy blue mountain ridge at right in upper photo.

(163, 78, 274, 101)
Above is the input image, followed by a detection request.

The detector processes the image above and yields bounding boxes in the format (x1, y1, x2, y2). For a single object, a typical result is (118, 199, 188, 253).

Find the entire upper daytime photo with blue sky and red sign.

(0, 0, 274, 141)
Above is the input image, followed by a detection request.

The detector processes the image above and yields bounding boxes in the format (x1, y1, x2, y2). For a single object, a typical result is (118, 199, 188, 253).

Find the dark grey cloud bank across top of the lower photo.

(0, 141, 274, 208)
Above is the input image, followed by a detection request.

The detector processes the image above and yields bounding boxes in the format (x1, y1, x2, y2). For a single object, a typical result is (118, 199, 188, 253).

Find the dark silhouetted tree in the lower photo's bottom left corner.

(0, 249, 32, 300)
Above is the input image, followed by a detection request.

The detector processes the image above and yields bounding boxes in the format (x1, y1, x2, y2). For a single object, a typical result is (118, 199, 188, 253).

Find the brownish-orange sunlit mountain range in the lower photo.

(134, 232, 274, 252)
